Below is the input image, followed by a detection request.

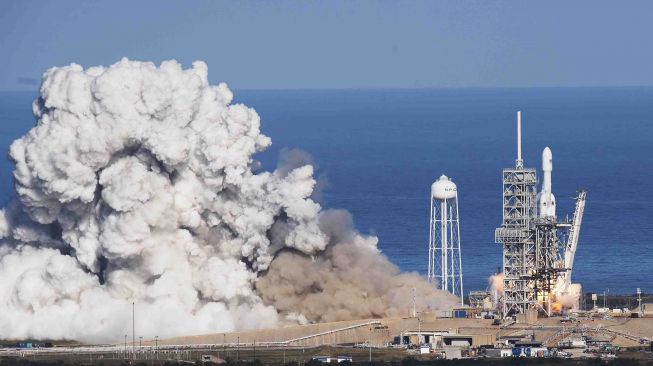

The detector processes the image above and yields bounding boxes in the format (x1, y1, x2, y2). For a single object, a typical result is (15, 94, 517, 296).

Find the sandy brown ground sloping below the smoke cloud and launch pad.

(0, 315, 653, 366)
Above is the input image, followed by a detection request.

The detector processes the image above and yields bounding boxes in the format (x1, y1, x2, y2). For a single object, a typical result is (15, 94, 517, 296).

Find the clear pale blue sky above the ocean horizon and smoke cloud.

(0, 0, 653, 90)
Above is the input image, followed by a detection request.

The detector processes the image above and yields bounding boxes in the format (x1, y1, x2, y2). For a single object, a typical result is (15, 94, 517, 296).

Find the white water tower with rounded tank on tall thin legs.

(428, 175, 463, 305)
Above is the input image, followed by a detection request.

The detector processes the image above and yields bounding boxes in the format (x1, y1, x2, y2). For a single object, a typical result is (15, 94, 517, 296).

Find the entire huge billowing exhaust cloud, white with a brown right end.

(0, 59, 454, 341)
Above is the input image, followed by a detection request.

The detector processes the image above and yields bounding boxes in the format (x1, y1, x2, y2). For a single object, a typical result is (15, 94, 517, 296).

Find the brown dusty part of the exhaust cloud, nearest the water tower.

(257, 210, 456, 321)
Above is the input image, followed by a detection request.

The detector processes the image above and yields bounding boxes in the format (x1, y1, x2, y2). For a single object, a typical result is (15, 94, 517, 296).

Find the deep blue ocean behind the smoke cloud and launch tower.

(0, 87, 653, 294)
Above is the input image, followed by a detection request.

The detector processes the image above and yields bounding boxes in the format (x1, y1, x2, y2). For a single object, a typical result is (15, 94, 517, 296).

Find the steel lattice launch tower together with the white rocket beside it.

(495, 112, 586, 316)
